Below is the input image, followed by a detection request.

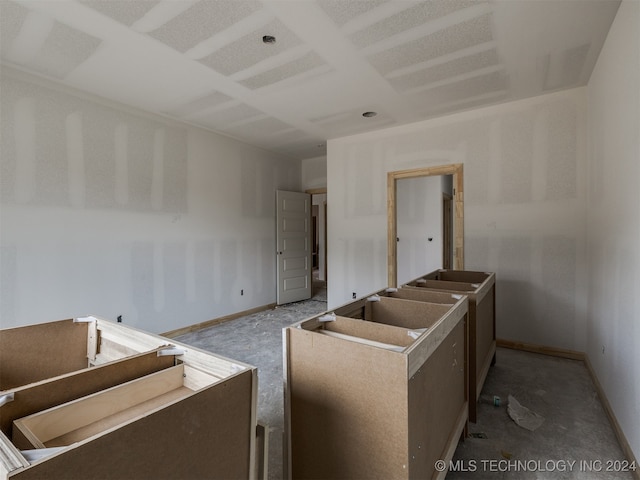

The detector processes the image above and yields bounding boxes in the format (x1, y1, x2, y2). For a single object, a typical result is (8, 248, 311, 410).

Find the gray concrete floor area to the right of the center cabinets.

(447, 348, 633, 480)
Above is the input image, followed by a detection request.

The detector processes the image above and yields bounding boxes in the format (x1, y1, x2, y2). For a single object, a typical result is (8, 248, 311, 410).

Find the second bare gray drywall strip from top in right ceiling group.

(350, 0, 478, 48)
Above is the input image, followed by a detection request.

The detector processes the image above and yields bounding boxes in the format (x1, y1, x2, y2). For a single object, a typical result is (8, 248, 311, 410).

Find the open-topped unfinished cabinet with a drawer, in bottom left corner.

(0, 317, 257, 480)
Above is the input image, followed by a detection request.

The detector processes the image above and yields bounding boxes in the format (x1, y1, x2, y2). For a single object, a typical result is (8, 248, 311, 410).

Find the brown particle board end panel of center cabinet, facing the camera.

(288, 328, 408, 479)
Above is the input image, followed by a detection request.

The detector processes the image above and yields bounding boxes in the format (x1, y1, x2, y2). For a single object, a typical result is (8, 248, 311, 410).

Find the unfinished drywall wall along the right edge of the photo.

(586, 1, 640, 459)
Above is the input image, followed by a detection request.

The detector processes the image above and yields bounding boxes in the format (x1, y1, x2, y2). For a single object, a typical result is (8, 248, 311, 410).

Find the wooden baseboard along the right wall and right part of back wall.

(496, 339, 640, 480)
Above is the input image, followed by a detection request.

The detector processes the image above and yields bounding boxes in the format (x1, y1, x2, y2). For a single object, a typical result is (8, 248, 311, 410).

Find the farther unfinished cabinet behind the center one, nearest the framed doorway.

(406, 270, 496, 422)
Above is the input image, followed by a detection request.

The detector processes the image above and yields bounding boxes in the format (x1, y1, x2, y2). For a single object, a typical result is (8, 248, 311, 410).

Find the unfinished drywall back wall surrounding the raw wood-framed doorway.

(327, 88, 587, 350)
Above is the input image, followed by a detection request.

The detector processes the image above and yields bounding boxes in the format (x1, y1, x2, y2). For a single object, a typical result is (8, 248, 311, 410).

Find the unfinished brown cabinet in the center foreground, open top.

(283, 296, 468, 479)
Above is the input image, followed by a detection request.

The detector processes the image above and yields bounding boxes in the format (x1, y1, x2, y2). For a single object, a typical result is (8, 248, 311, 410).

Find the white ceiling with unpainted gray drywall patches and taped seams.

(0, 0, 619, 158)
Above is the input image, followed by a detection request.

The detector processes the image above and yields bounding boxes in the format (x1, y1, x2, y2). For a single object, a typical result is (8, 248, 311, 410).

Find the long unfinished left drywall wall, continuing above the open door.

(0, 67, 301, 332)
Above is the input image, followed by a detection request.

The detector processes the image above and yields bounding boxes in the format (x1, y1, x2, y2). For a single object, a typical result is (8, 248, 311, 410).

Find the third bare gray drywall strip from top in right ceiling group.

(369, 14, 493, 75)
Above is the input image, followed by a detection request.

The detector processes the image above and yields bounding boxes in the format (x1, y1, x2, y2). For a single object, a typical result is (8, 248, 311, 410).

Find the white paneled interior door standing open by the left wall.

(276, 190, 311, 305)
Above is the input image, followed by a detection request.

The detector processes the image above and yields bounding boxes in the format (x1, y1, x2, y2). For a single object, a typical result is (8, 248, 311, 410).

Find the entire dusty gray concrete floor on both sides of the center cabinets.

(176, 282, 633, 480)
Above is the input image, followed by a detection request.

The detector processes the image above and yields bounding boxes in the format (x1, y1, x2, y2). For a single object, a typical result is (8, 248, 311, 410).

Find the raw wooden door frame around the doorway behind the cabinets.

(387, 163, 464, 287)
